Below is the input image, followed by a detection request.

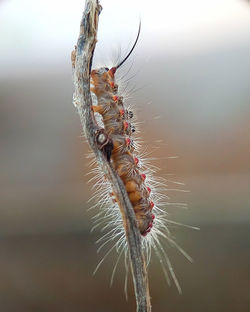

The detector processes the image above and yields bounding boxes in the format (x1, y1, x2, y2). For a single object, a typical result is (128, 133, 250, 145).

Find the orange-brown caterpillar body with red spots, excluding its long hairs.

(91, 67, 155, 236)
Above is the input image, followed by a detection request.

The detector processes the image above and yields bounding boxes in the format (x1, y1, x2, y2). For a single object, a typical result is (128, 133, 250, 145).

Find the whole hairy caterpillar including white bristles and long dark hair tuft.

(86, 21, 197, 291)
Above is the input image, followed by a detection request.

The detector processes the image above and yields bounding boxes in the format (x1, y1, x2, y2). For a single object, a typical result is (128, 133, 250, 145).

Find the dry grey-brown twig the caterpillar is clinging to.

(72, 0, 151, 312)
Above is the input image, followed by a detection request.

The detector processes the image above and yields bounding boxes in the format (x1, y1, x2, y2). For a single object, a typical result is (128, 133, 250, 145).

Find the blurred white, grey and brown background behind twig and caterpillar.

(0, 0, 250, 312)
